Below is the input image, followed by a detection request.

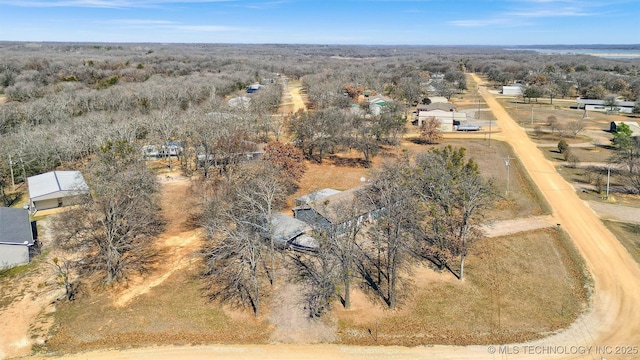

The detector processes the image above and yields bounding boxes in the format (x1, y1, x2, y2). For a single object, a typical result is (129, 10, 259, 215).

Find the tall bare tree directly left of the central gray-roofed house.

(202, 163, 285, 317)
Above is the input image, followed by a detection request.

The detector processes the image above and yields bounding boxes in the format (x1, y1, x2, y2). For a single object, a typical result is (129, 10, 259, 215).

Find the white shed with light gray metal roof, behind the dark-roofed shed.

(27, 171, 89, 211)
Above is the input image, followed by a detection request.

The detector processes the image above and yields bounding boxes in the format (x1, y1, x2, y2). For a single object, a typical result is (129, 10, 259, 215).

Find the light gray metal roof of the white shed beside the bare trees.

(27, 171, 89, 201)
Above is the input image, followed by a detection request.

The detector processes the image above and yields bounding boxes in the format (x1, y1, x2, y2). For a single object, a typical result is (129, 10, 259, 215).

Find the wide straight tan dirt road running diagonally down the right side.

(474, 75, 640, 358)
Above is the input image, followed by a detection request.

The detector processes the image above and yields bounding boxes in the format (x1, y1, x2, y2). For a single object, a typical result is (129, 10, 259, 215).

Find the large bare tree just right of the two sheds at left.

(55, 140, 162, 283)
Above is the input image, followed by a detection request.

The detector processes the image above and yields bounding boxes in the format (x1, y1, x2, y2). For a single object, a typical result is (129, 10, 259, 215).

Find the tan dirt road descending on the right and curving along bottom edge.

(36, 75, 640, 360)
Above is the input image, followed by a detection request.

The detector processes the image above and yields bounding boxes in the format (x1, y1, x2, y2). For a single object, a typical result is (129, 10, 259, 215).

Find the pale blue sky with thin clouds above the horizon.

(0, 0, 640, 45)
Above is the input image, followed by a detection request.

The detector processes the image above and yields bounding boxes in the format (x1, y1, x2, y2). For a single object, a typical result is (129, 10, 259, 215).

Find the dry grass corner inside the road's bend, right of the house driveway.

(337, 230, 586, 345)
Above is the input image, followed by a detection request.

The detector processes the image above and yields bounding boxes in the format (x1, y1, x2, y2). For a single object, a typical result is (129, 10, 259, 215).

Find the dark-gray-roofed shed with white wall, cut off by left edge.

(0, 207, 34, 269)
